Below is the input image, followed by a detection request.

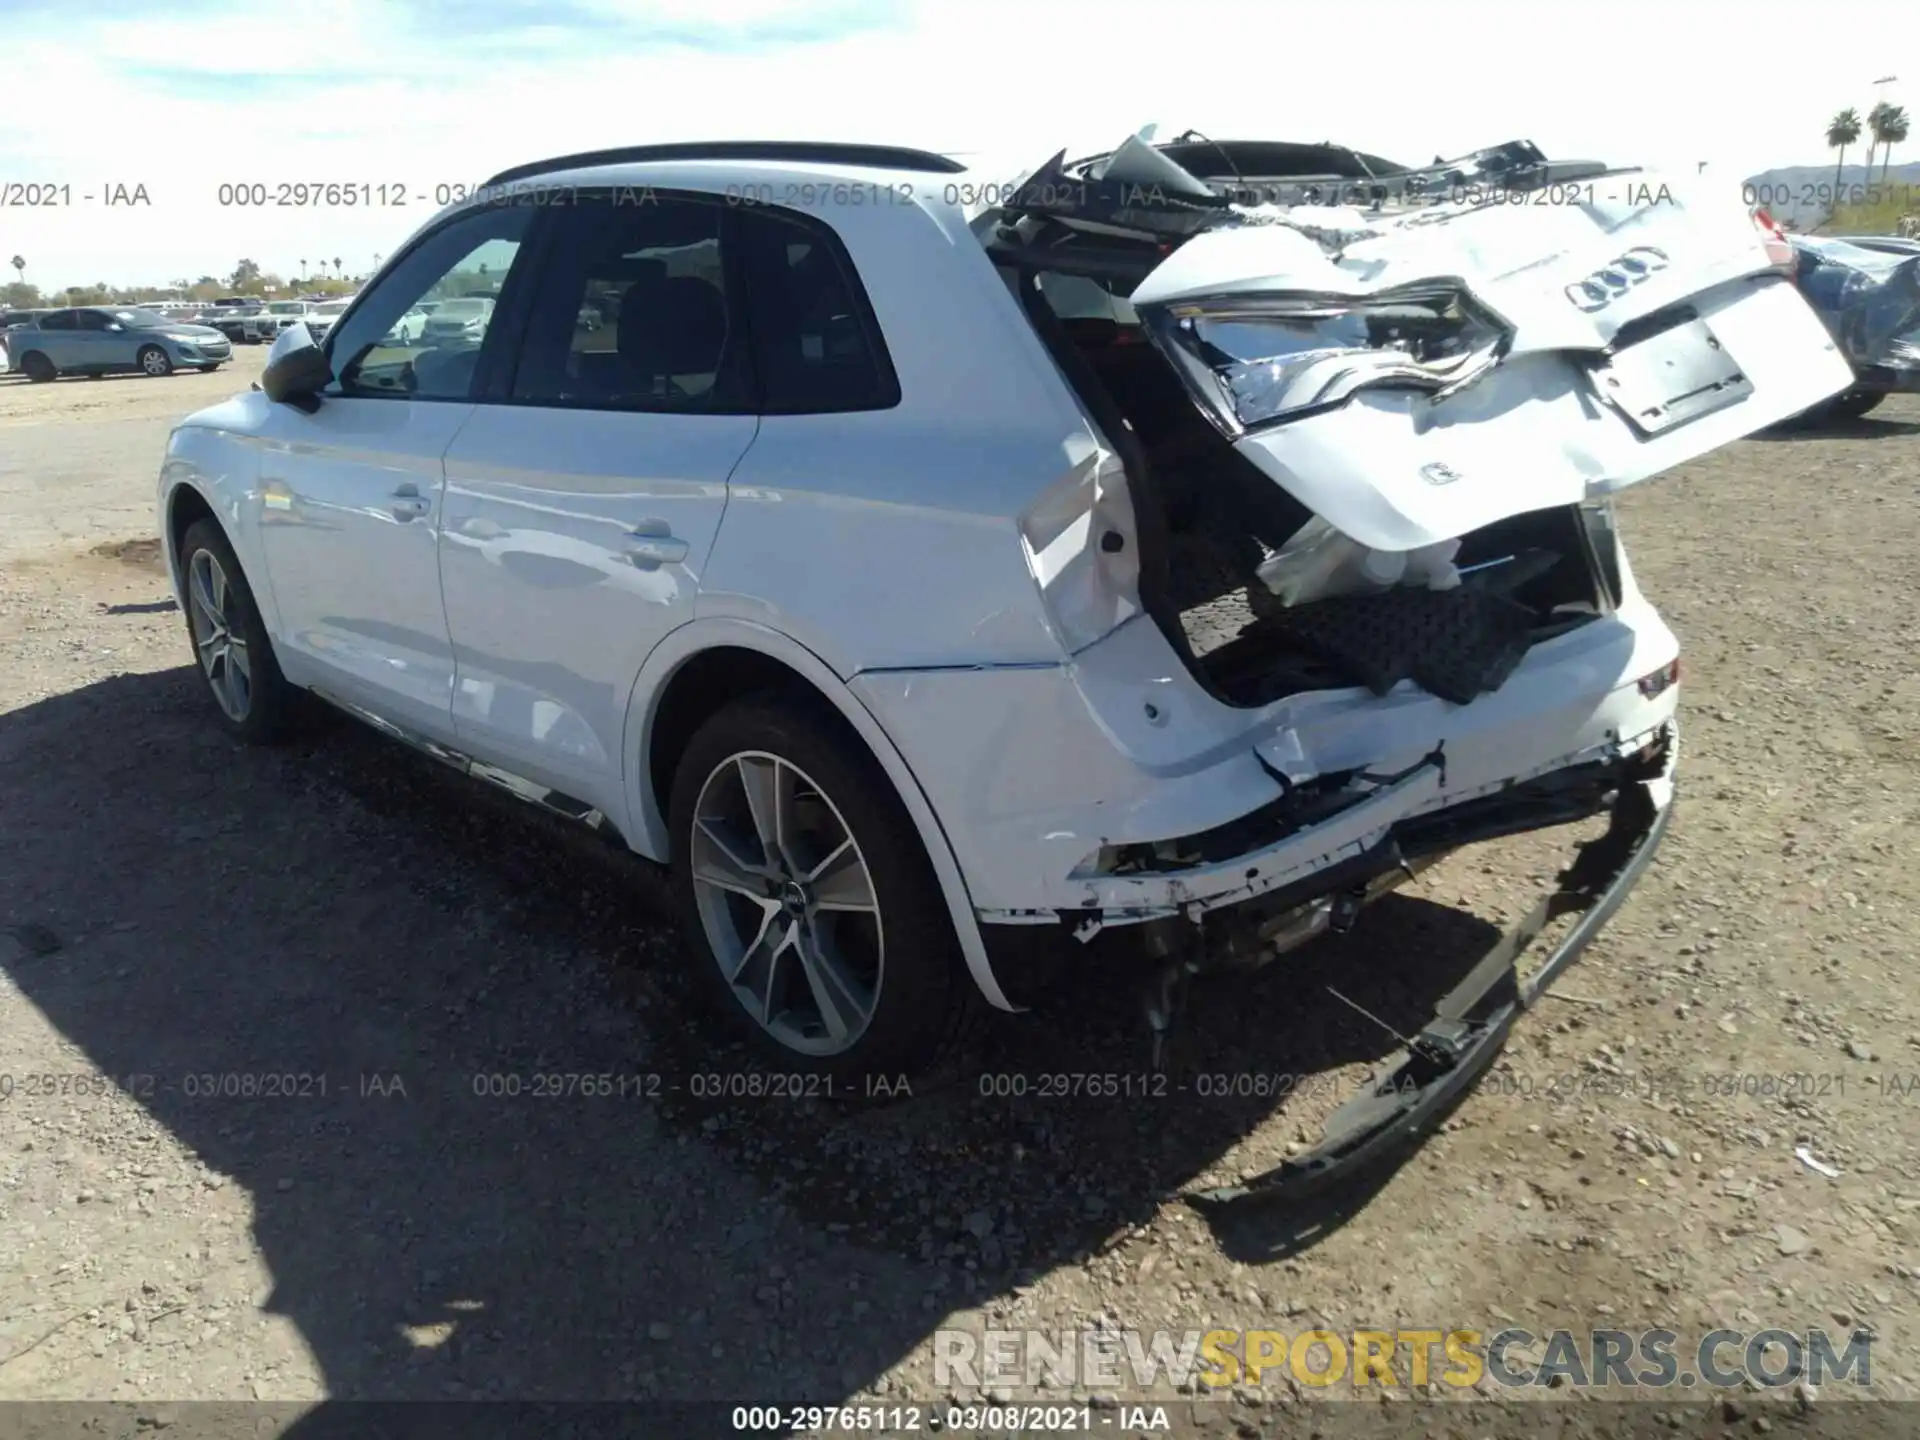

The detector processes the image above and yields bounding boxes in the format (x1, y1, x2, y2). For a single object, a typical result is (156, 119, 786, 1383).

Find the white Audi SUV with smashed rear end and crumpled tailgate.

(159, 138, 1849, 1182)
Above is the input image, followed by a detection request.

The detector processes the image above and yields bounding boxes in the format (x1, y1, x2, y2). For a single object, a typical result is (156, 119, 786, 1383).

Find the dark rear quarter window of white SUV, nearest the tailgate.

(732, 209, 900, 415)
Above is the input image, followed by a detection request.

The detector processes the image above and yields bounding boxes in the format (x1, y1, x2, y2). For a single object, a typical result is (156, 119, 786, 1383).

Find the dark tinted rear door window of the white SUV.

(510, 192, 753, 415)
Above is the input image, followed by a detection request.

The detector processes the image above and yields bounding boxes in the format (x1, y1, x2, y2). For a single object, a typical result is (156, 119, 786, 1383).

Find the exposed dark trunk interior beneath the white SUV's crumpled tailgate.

(1027, 280, 1611, 707)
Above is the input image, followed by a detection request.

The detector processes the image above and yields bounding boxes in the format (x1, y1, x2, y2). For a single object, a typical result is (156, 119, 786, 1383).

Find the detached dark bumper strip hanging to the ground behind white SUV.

(1188, 728, 1680, 1208)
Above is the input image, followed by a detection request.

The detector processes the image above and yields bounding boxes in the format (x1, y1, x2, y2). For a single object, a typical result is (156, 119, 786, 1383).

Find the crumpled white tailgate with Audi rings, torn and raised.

(989, 128, 1850, 551)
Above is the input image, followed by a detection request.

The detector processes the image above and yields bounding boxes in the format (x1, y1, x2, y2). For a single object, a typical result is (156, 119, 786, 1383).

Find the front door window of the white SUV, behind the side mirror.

(315, 205, 536, 399)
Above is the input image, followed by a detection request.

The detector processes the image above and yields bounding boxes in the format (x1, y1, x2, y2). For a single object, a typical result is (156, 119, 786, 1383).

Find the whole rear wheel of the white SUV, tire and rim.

(668, 695, 975, 1079)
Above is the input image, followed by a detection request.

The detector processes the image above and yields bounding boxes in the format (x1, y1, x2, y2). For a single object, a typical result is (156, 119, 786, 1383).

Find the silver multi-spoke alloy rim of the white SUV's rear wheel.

(687, 751, 885, 1056)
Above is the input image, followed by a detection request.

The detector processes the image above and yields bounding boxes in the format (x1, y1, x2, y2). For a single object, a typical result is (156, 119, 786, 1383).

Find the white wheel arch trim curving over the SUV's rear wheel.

(626, 616, 1020, 1010)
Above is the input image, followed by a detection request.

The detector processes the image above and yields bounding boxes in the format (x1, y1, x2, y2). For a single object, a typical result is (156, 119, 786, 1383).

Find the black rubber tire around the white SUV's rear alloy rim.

(668, 693, 981, 1081)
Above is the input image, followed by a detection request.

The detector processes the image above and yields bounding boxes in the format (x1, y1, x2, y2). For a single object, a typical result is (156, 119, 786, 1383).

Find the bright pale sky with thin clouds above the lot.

(0, 0, 1920, 286)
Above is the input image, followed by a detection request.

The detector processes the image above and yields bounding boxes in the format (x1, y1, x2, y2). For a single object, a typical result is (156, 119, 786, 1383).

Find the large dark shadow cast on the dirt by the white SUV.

(0, 668, 1492, 1404)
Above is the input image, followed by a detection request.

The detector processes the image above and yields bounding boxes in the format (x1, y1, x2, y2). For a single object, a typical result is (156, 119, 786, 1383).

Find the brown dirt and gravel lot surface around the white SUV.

(0, 351, 1920, 1434)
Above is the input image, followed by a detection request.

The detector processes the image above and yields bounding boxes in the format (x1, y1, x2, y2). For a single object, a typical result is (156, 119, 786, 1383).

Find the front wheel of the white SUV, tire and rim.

(180, 520, 296, 745)
